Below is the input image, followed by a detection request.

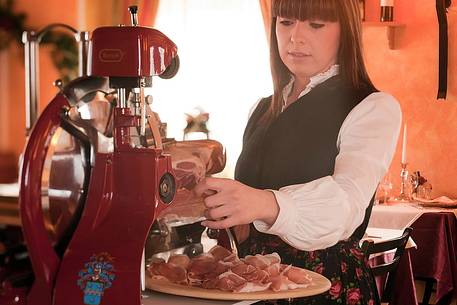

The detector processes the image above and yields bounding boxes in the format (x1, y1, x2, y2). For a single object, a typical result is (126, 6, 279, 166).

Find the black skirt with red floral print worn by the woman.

(241, 230, 377, 305)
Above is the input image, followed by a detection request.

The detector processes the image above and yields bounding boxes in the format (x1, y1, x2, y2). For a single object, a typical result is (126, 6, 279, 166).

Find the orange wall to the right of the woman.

(364, 0, 457, 197)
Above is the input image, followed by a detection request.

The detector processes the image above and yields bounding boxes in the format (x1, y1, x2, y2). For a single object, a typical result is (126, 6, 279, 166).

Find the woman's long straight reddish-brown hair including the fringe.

(261, 0, 374, 124)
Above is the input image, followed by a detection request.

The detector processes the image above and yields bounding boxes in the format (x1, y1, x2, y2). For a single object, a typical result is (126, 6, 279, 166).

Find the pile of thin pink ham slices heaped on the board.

(147, 246, 312, 292)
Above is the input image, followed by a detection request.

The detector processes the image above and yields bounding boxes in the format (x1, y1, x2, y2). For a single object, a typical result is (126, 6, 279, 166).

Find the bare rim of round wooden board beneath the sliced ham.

(146, 270, 331, 300)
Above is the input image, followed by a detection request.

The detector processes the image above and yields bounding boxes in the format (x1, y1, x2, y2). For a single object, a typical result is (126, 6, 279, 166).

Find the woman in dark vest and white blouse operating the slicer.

(196, 0, 401, 304)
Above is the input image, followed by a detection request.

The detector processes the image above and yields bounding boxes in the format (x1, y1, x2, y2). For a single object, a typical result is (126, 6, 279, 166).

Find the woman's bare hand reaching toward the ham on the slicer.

(194, 178, 279, 229)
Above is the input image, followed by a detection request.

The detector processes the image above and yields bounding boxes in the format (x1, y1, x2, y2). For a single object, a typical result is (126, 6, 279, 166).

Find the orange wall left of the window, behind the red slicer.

(0, 0, 116, 162)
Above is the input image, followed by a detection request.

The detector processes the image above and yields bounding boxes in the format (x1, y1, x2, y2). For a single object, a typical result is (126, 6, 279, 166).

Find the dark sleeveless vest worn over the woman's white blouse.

(235, 76, 375, 245)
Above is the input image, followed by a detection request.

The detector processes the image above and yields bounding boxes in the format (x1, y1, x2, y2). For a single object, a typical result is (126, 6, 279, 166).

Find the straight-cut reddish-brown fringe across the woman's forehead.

(272, 0, 338, 22)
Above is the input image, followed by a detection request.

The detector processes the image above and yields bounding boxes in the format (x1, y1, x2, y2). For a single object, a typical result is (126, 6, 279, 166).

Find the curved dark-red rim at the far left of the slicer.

(19, 94, 69, 305)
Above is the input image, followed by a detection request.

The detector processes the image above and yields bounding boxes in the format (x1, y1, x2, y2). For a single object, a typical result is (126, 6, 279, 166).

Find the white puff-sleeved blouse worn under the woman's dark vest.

(254, 66, 402, 251)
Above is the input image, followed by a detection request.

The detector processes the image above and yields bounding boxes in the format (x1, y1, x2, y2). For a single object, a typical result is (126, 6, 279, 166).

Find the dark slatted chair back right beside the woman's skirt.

(362, 227, 413, 304)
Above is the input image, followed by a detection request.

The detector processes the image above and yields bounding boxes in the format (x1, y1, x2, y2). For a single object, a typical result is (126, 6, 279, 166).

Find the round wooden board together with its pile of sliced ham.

(146, 246, 330, 300)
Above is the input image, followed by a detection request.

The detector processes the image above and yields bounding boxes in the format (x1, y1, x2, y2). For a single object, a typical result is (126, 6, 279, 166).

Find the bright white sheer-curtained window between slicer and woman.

(152, 0, 272, 177)
